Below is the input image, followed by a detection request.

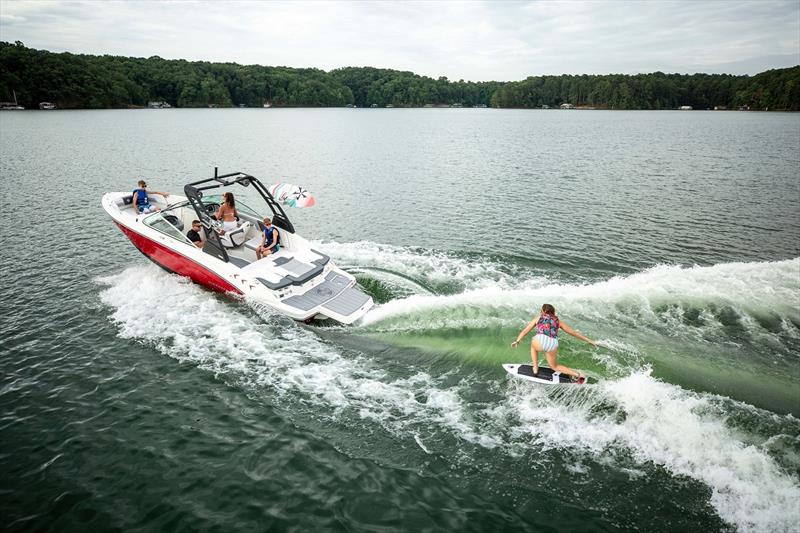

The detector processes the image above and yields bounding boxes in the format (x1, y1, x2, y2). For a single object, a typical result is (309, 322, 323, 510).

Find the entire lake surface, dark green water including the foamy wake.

(0, 109, 800, 532)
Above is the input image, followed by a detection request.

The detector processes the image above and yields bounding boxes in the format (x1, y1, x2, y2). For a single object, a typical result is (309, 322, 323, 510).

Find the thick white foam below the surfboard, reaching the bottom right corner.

(507, 372, 800, 532)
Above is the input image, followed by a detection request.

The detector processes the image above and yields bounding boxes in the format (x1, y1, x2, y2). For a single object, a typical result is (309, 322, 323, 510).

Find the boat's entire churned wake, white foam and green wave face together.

(98, 242, 800, 531)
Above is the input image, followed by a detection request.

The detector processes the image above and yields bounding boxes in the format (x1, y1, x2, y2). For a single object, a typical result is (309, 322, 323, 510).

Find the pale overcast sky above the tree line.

(0, 0, 800, 81)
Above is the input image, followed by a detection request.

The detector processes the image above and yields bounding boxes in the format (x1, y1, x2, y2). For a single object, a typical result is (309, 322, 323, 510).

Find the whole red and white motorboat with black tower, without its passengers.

(102, 169, 373, 324)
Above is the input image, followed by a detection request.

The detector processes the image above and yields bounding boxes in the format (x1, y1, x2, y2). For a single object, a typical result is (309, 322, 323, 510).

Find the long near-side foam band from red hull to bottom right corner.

(101, 261, 800, 531)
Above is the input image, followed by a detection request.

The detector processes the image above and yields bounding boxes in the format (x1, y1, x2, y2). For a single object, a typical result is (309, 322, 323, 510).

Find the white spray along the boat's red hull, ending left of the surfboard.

(99, 265, 492, 446)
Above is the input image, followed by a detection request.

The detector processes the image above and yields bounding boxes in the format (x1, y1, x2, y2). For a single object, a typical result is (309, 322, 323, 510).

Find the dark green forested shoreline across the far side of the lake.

(0, 42, 800, 111)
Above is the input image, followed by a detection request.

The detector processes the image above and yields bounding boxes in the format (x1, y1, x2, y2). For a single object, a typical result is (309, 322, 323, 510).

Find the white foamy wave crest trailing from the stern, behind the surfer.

(363, 258, 800, 335)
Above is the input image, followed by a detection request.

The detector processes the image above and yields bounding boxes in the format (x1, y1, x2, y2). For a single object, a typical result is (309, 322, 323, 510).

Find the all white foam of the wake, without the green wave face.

(99, 247, 800, 531)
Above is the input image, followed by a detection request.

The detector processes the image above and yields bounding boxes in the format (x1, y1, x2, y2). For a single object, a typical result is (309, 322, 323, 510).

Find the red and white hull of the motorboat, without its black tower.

(102, 192, 373, 324)
